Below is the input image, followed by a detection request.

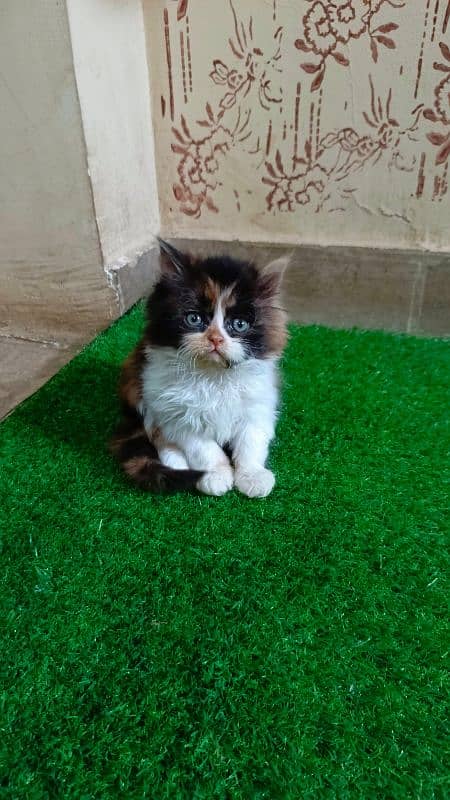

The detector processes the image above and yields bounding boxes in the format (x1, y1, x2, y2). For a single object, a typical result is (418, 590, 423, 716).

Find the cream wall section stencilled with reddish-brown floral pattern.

(145, 0, 450, 249)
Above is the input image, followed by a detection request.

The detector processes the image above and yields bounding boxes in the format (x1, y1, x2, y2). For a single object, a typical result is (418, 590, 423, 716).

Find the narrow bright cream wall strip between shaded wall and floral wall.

(67, 0, 159, 270)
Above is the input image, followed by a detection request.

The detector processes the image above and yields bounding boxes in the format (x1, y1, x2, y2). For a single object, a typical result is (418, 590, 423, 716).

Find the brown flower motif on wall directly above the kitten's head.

(172, 109, 250, 218)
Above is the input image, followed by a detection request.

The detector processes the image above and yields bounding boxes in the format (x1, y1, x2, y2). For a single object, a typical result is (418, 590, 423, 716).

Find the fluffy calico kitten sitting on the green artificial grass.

(112, 241, 288, 497)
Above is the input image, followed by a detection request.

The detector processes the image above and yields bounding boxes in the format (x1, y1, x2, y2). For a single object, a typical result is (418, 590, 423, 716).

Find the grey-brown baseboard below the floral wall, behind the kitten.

(171, 239, 450, 337)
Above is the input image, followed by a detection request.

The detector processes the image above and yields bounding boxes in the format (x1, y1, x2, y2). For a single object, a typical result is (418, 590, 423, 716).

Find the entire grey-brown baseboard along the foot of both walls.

(0, 239, 450, 418)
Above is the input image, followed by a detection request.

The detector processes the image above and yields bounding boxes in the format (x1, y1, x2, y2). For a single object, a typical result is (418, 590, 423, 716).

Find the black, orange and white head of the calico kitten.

(148, 242, 286, 369)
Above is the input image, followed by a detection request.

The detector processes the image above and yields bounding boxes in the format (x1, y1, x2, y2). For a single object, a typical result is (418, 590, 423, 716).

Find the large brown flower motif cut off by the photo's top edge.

(295, 0, 405, 92)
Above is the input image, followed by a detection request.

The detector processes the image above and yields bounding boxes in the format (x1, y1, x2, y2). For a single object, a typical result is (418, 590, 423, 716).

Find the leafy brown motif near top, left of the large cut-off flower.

(210, 0, 283, 115)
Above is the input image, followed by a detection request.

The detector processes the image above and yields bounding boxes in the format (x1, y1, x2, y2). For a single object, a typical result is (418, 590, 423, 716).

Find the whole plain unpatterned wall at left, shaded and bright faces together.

(0, 0, 159, 344)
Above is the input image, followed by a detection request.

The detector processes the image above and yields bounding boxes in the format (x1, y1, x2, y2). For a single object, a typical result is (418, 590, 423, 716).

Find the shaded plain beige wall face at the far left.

(0, 0, 116, 339)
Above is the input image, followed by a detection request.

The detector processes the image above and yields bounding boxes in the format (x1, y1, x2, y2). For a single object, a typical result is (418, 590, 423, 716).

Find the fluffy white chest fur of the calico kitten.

(142, 348, 277, 445)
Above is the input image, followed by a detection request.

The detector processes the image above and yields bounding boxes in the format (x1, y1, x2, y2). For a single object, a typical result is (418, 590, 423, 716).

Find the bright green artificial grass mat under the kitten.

(0, 307, 450, 800)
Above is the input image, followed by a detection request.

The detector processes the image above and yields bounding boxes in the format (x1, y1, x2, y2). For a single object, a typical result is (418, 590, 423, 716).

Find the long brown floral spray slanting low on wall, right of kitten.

(262, 78, 422, 212)
